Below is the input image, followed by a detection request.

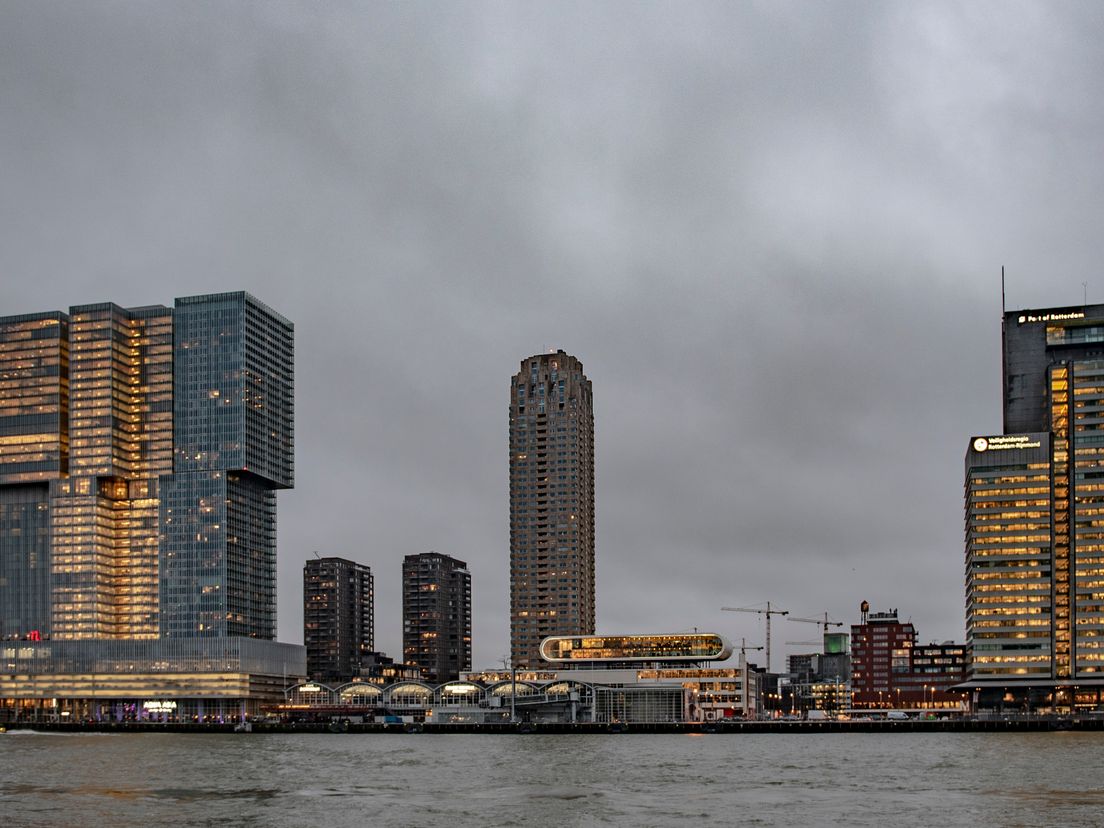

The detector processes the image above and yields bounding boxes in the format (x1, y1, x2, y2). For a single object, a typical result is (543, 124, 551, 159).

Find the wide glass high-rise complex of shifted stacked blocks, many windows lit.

(0, 293, 302, 724)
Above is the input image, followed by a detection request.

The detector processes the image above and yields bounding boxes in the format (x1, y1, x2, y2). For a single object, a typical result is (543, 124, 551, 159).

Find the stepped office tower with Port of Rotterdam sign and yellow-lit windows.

(965, 305, 1104, 711)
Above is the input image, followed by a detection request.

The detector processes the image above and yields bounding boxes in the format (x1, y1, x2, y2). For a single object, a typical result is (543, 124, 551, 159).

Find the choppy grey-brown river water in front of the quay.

(0, 732, 1104, 828)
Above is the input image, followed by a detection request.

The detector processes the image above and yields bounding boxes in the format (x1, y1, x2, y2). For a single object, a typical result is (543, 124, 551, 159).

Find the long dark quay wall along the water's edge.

(4, 716, 1104, 736)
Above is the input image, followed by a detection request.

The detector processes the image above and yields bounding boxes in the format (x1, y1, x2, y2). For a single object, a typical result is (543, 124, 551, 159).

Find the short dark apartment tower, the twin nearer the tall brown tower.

(403, 552, 471, 683)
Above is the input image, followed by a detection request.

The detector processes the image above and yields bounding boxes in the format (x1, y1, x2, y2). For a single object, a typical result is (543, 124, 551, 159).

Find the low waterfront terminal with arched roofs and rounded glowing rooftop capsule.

(278, 633, 758, 724)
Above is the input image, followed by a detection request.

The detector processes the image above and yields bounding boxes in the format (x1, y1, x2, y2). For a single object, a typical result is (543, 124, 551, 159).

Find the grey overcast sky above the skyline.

(0, 0, 1104, 668)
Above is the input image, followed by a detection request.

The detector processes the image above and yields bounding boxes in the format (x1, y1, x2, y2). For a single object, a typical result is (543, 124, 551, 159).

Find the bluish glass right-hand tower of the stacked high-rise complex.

(160, 294, 294, 638)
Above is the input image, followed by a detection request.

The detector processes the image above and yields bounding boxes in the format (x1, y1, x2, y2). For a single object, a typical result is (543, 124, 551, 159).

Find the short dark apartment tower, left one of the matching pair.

(302, 558, 379, 684)
